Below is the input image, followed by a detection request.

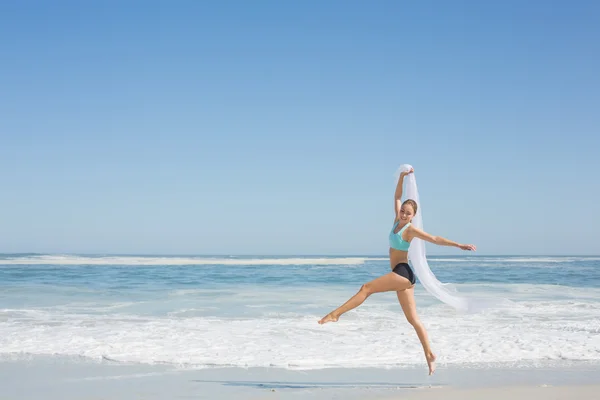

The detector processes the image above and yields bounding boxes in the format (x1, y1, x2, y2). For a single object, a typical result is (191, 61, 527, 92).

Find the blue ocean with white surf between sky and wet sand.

(0, 254, 600, 370)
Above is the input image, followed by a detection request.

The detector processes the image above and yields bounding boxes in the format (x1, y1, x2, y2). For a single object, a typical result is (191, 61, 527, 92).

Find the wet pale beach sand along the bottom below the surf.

(0, 356, 600, 400)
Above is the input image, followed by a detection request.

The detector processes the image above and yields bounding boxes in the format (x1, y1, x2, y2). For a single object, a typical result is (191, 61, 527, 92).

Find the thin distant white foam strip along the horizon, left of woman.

(0, 255, 367, 265)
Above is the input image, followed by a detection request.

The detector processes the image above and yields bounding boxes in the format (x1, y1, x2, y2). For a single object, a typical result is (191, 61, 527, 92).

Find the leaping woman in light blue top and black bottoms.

(319, 168, 476, 375)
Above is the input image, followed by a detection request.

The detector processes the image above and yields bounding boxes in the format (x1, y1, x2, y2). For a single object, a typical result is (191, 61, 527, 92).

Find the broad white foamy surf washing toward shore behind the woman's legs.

(0, 287, 600, 369)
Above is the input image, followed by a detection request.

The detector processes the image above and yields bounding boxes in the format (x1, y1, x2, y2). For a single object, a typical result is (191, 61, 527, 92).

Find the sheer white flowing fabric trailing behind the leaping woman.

(396, 164, 503, 312)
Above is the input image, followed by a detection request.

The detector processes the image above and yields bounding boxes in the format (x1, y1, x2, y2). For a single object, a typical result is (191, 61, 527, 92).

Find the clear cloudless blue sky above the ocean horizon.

(0, 0, 600, 255)
